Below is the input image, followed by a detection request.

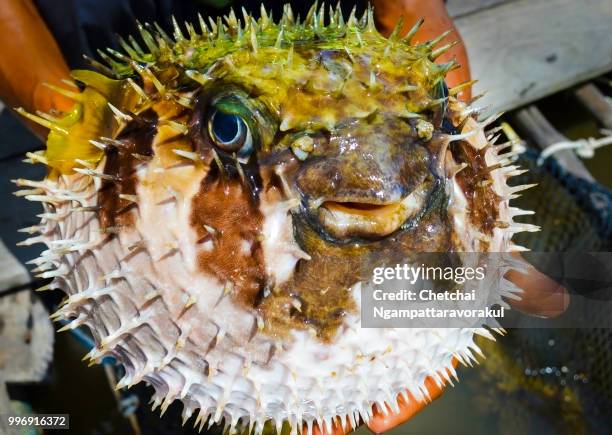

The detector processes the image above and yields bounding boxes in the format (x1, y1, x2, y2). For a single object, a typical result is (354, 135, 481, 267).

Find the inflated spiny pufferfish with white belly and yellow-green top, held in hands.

(16, 2, 537, 434)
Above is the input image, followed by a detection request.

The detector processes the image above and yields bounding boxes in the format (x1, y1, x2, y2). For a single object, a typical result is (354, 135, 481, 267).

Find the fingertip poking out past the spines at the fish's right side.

(506, 253, 569, 317)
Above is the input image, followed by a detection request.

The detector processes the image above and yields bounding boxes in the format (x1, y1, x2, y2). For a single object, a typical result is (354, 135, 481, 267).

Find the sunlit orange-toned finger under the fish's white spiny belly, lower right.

(368, 358, 457, 433)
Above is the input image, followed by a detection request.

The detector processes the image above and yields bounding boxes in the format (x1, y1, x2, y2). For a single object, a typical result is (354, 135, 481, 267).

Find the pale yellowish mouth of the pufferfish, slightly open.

(314, 188, 427, 240)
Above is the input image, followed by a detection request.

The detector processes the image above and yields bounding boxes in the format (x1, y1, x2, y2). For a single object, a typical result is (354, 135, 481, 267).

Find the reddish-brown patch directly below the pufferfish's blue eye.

(191, 176, 265, 308)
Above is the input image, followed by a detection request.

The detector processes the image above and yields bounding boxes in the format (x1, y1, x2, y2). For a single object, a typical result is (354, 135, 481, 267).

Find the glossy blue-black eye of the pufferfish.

(208, 109, 253, 157)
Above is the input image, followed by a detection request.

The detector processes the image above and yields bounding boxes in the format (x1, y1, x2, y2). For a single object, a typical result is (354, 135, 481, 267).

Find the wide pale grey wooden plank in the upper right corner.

(456, 0, 612, 112)
